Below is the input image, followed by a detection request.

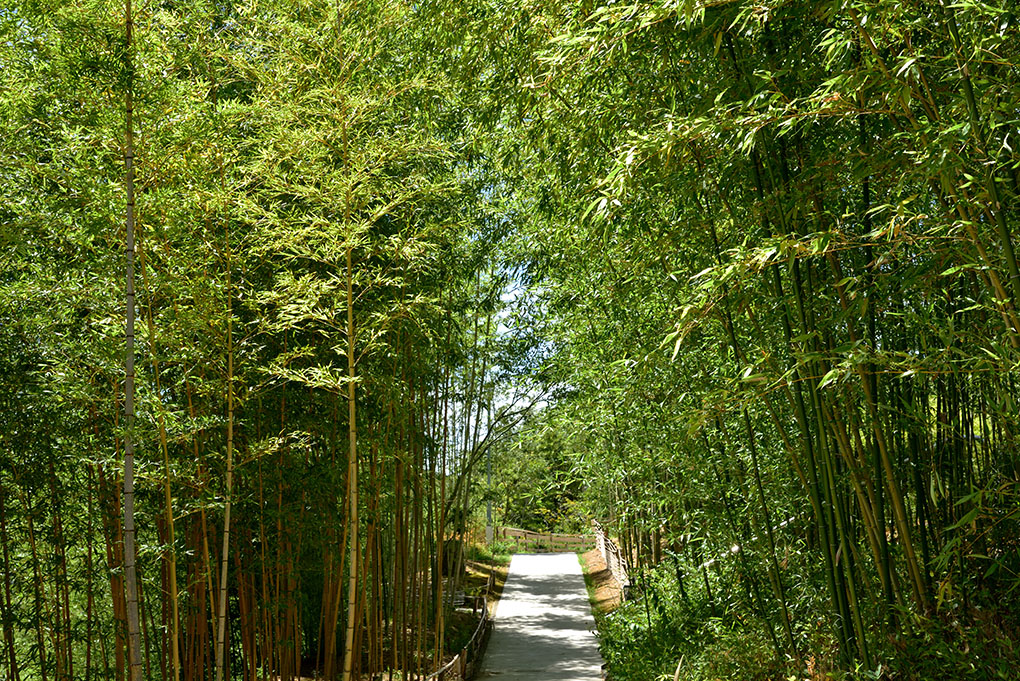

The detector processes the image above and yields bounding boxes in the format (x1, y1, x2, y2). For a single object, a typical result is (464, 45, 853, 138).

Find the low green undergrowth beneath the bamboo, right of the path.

(597, 564, 1020, 681)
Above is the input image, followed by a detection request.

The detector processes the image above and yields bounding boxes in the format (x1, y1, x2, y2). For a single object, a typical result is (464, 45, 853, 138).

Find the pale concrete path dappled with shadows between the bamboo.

(477, 554, 602, 681)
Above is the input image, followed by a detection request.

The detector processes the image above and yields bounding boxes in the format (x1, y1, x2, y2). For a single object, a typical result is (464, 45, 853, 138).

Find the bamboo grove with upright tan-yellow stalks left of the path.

(0, 0, 519, 681)
